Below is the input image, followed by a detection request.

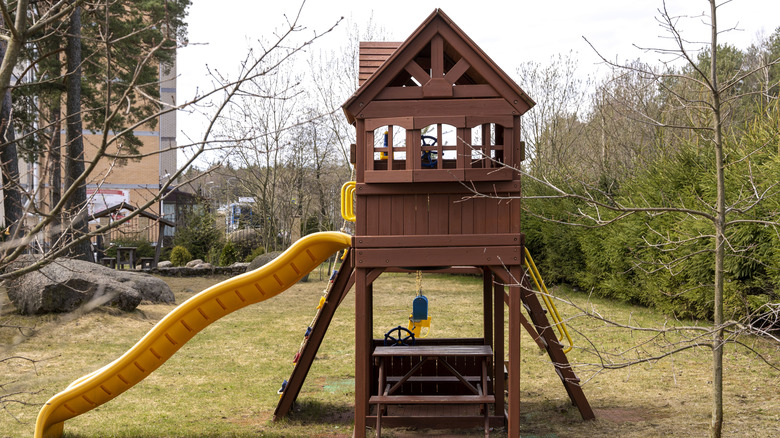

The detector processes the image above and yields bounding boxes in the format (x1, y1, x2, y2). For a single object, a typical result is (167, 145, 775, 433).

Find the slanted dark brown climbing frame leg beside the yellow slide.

(274, 252, 355, 421)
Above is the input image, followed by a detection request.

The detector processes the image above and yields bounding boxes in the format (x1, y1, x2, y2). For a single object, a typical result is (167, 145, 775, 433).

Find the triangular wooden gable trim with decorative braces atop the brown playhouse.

(342, 9, 535, 123)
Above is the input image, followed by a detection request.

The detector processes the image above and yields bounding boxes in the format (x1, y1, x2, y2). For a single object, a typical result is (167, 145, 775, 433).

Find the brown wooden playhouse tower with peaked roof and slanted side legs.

(275, 9, 593, 437)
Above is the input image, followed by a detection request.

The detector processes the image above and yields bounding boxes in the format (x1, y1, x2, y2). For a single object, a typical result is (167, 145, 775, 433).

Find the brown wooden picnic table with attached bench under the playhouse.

(368, 345, 496, 437)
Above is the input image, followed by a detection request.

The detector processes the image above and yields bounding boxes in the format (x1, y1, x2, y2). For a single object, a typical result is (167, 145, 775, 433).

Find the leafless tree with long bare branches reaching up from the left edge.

(0, 2, 340, 278)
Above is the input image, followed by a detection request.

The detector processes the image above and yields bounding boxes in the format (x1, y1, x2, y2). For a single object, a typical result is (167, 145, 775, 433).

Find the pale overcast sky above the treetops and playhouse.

(177, 0, 780, 162)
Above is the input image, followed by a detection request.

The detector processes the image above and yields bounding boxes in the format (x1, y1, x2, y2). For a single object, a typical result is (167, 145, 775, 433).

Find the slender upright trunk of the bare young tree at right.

(710, 0, 726, 438)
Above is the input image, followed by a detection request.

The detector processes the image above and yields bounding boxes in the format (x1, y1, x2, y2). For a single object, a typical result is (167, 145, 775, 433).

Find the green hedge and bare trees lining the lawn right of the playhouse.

(508, 4, 780, 437)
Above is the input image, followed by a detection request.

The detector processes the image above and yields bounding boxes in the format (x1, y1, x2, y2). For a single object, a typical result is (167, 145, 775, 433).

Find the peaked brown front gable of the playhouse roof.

(342, 8, 536, 123)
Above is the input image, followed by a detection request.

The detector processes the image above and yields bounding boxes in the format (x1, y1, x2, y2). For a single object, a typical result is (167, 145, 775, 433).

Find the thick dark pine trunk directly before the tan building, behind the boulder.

(65, 7, 92, 260)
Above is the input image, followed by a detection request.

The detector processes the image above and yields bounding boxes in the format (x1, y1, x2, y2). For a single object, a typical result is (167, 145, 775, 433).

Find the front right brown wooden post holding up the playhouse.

(507, 265, 523, 438)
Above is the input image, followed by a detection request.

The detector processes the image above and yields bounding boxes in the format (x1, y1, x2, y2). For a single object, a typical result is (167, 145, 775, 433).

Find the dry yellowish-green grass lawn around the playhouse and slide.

(0, 266, 780, 437)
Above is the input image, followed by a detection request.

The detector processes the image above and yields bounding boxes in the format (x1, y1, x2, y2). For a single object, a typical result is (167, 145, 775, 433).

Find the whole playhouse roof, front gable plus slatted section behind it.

(342, 9, 536, 123)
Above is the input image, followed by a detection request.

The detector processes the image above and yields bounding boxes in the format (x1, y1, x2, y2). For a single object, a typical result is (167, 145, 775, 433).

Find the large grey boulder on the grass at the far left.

(4, 256, 175, 315)
